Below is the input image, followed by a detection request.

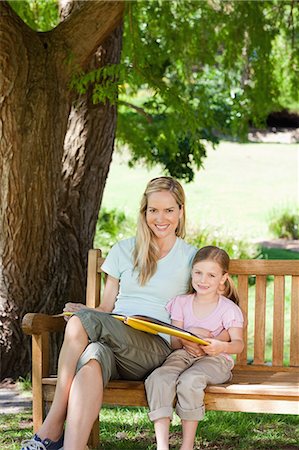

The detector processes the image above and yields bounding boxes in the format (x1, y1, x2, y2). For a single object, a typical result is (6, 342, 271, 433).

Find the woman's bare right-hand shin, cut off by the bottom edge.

(63, 360, 103, 450)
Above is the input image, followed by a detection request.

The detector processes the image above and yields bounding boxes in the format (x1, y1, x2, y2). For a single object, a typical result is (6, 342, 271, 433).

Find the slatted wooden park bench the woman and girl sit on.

(22, 250, 299, 447)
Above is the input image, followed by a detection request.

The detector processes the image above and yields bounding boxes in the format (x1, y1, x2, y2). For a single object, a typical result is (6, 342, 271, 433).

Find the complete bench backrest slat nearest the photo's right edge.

(272, 275, 285, 367)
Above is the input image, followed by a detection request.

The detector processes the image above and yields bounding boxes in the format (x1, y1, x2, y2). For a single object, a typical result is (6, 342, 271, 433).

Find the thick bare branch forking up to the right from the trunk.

(51, 0, 125, 68)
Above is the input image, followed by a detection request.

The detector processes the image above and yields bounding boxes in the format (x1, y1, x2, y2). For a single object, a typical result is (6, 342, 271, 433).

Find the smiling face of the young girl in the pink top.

(191, 260, 228, 296)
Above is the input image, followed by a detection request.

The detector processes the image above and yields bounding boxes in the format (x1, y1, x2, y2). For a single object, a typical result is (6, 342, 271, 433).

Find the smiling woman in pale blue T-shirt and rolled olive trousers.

(22, 177, 196, 450)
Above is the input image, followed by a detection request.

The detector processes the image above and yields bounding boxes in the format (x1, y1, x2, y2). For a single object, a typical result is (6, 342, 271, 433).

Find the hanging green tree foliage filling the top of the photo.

(11, 0, 299, 181)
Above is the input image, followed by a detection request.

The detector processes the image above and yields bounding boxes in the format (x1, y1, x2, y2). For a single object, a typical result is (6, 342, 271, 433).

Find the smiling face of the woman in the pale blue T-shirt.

(146, 191, 183, 239)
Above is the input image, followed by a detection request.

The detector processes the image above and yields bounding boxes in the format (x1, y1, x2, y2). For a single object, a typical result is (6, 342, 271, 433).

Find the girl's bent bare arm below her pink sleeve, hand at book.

(201, 327, 244, 356)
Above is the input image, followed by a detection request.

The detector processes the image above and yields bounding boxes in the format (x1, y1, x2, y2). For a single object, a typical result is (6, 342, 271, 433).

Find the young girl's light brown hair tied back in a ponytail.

(188, 245, 239, 305)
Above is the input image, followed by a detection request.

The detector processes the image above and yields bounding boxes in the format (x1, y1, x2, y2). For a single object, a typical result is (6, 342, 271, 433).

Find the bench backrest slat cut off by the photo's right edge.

(290, 276, 299, 367)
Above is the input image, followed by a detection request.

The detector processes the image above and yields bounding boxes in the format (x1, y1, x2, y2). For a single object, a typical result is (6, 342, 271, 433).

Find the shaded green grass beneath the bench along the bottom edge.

(0, 408, 299, 450)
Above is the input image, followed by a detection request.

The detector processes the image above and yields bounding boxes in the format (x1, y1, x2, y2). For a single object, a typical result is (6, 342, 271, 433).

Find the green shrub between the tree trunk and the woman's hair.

(94, 208, 135, 256)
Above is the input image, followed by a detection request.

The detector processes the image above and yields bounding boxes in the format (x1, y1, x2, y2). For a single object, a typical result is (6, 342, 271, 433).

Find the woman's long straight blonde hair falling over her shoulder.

(133, 177, 186, 286)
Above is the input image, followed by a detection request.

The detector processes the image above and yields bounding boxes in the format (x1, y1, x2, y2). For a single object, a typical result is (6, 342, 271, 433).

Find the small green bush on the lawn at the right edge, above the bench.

(269, 209, 299, 239)
